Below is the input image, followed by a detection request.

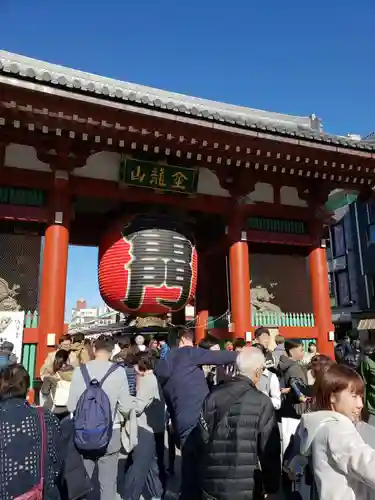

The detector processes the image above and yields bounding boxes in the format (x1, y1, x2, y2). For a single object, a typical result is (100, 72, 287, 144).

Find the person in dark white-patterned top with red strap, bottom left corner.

(0, 364, 63, 500)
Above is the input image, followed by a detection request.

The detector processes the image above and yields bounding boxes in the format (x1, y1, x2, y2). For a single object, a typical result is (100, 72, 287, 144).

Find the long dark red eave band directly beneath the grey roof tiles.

(0, 85, 375, 169)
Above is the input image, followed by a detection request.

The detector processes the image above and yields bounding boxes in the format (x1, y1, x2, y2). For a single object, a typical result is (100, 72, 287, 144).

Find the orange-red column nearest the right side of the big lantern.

(228, 211, 251, 338)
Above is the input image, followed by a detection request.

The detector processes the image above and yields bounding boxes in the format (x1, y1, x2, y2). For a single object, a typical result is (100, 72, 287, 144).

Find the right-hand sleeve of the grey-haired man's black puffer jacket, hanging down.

(258, 399, 281, 495)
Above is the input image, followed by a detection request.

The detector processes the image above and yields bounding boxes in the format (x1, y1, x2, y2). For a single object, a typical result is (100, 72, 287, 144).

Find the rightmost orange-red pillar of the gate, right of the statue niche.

(309, 245, 335, 359)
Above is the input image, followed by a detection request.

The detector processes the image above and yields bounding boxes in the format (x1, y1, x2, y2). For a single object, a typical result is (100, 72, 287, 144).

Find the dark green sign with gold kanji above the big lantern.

(120, 158, 198, 194)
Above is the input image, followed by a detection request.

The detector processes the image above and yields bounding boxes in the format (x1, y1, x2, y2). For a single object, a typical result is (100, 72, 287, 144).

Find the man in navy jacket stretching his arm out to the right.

(155, 328, 238, 500)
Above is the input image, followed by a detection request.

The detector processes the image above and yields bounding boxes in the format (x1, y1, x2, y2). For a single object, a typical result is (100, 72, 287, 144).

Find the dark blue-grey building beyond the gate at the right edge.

(327, 199, 375, 338)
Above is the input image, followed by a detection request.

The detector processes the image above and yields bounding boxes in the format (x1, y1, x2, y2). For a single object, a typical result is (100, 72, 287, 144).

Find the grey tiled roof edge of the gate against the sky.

(0, 51, 375, 152)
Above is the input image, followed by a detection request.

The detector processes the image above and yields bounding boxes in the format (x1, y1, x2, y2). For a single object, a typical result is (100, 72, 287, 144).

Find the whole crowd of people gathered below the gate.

(0, 327, 375, 500)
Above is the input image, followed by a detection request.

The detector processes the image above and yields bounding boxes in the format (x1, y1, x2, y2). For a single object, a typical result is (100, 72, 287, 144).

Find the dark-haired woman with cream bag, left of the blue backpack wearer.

(41, 349, 74, 420)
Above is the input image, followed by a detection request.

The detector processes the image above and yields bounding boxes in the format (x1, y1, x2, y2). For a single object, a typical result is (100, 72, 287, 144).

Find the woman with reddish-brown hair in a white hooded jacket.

(289, 364, 375, 500)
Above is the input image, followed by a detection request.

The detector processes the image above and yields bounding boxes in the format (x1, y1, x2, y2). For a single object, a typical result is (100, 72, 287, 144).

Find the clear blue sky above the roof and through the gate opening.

(0, 0, 375, 310)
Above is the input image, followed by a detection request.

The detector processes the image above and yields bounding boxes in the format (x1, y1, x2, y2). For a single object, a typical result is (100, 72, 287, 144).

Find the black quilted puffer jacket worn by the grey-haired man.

(201, 376, 281, 500)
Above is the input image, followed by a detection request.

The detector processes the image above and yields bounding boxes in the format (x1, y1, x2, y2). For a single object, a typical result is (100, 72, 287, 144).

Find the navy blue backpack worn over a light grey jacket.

(74, 364, 118, 456)
